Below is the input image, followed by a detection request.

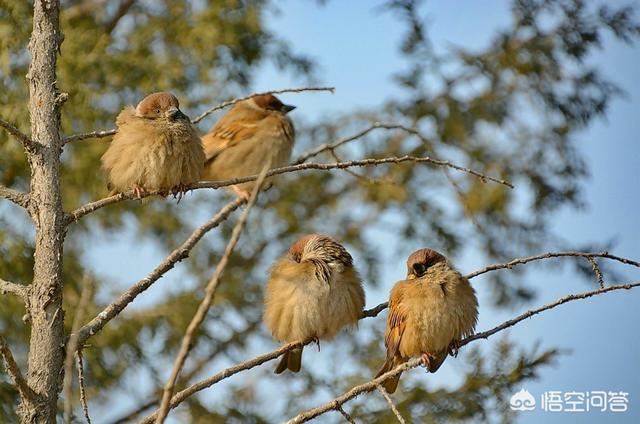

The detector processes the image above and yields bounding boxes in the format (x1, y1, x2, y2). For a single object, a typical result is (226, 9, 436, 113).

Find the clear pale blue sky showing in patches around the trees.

(90, 0, 640, 423)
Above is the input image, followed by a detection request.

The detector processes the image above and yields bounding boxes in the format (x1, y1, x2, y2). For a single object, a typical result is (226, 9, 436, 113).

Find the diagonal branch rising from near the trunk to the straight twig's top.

(75, 198, 246, 349)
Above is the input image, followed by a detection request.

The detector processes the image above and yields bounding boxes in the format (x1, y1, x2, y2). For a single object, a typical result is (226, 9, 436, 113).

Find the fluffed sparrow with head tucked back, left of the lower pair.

(264, 234, 364, 374)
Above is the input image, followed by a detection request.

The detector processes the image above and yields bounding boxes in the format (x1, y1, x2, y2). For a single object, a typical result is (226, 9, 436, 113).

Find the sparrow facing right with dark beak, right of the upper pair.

(202, 94, 295, 199)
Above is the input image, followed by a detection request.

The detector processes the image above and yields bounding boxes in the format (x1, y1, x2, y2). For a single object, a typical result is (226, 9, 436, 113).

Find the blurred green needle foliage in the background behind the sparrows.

(0, 0, 640, 423)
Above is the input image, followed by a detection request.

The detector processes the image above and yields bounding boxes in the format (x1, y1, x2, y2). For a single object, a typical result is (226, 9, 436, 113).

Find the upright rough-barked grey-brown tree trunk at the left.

(19, 0, 66, 423)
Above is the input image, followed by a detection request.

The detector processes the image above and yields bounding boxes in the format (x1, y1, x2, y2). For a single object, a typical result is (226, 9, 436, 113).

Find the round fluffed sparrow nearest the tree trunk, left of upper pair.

(102, 92, 205, 198)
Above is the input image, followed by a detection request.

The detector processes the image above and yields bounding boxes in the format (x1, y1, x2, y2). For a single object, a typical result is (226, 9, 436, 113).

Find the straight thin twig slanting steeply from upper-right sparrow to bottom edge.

(156, 162, 271, 424)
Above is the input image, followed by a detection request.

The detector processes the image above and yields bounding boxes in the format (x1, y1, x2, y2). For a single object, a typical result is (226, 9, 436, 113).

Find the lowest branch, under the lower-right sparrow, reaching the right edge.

(287, 282, 640, 424)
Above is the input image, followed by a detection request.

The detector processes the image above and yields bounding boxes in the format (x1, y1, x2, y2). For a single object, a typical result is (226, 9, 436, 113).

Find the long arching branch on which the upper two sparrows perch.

(66, 156, 513, 224)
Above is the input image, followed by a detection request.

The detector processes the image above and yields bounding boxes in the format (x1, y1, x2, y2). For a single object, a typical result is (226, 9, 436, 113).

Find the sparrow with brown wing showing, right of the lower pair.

(376, 249, 478, 393)
